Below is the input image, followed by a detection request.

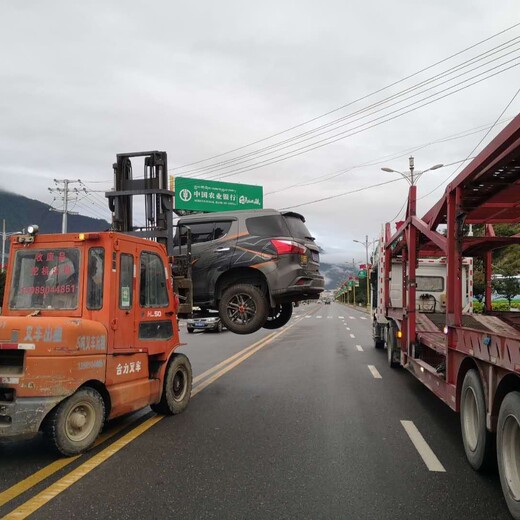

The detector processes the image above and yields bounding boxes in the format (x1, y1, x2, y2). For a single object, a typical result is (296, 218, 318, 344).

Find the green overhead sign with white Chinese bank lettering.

(174, 177, 263, 211)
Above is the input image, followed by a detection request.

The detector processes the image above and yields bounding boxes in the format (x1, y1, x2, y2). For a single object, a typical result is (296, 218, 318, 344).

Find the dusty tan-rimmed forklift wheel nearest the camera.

(43, 387, 105, 457)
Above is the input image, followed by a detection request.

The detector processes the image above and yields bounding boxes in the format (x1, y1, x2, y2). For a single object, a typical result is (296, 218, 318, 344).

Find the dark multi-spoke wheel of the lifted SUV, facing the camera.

(218, 284, 269, 334)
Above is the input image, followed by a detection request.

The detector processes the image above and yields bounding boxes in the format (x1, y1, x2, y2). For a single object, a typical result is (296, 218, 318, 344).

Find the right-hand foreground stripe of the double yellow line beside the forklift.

(4, 415, 164, 520)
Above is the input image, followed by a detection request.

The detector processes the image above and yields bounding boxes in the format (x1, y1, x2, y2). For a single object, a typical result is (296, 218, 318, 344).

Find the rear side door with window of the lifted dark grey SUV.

(181, 218, 237, 307)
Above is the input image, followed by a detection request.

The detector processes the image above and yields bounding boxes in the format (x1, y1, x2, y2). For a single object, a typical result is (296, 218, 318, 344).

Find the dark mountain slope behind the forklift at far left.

(0, 191, 110, 235)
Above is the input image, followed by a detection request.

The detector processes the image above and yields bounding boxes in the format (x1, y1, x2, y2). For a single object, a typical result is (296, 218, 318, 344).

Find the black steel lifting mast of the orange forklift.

(105, 151, 193, 317)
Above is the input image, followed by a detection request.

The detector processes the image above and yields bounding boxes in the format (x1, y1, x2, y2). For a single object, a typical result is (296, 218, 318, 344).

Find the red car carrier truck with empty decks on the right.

(373, 115, 520, 519)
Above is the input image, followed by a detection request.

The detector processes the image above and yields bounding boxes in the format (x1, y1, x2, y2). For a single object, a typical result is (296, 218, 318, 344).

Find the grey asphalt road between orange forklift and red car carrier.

(0, 304, 509, 520)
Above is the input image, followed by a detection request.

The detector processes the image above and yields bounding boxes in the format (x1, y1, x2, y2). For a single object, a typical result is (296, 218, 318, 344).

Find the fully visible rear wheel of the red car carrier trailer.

(460, 369, 493, 471)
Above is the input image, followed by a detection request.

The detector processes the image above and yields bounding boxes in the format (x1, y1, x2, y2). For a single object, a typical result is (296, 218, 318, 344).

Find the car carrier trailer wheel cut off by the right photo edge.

(497, 392, 520, 520)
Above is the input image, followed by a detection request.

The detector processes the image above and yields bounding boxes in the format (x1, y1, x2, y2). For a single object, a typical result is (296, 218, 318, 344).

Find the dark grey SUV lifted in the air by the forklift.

(175, 209, 324, 334)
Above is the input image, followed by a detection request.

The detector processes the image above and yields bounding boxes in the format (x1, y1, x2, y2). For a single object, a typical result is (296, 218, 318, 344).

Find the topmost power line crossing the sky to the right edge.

(170, 22, 520, 170)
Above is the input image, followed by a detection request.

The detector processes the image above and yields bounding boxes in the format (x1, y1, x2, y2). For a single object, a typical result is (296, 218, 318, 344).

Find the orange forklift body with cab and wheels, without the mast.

(0, 226, 192, 456)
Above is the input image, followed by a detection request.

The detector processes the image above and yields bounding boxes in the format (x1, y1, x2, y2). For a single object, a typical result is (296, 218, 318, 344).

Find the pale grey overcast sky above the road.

(0, 0, 520, 268)
